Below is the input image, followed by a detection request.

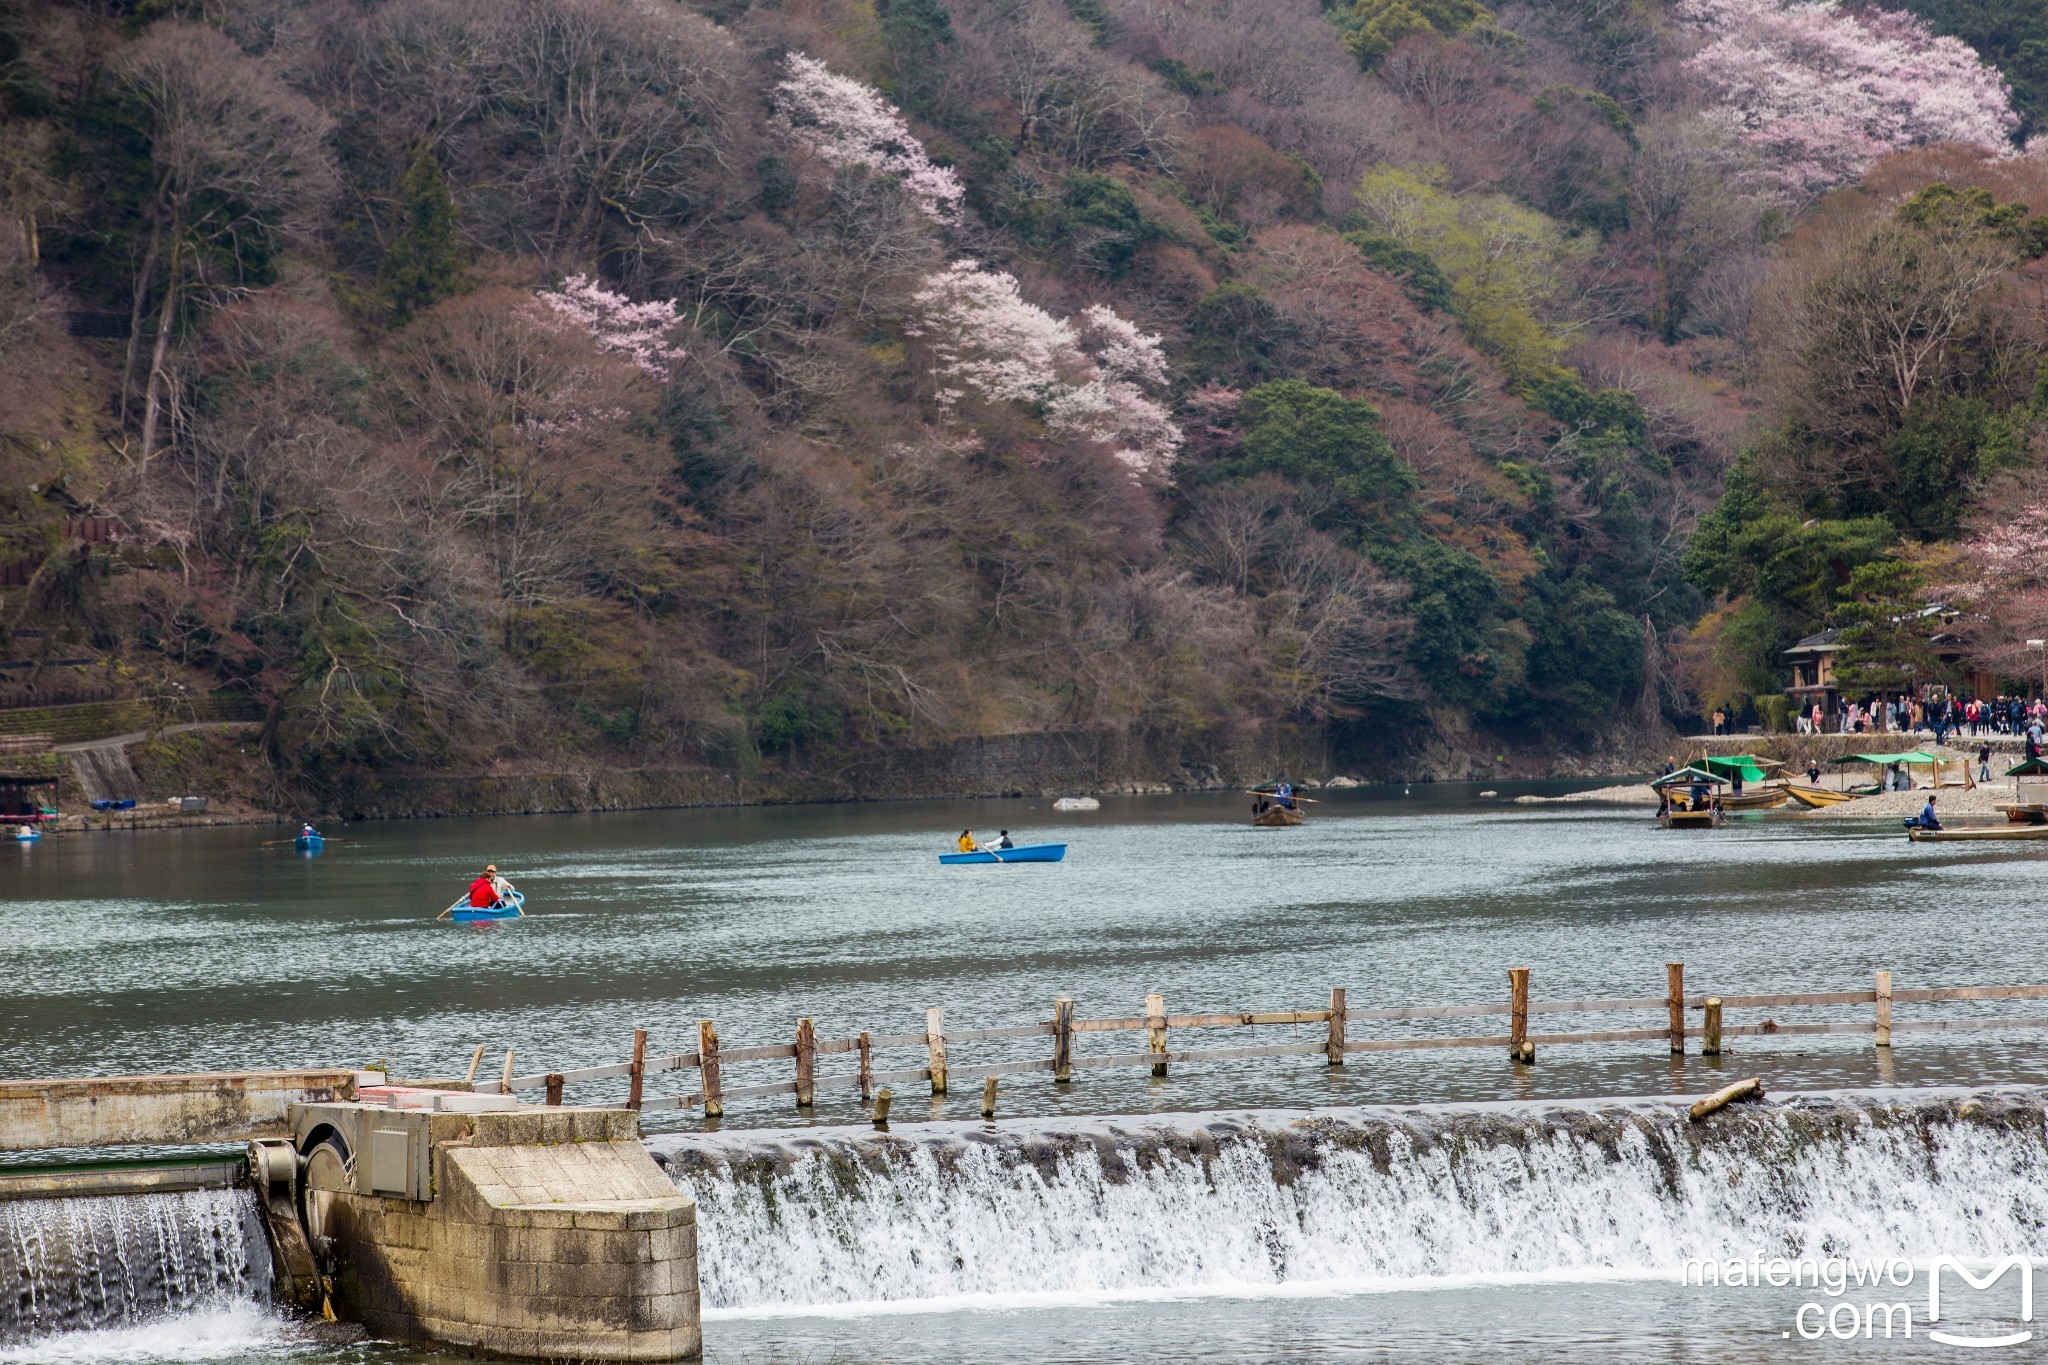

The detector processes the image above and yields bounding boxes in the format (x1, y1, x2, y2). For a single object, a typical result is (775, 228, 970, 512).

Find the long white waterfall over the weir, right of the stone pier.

(653, 1087, 2048, 1314)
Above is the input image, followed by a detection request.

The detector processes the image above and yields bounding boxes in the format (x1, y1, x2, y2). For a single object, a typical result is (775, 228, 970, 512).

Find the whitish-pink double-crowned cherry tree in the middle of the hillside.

(905, 260, 1182, 479)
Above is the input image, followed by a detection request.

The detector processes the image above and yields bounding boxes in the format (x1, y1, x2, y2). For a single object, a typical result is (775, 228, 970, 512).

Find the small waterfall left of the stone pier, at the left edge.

(0, 1189, 270, 1342)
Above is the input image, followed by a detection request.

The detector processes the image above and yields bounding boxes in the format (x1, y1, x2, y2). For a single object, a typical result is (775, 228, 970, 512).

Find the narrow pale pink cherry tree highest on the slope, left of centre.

(774, 51, 965, 223)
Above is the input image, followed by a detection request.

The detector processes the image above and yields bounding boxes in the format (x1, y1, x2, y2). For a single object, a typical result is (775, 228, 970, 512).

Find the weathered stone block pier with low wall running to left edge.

(0, 1072, 702, 1363)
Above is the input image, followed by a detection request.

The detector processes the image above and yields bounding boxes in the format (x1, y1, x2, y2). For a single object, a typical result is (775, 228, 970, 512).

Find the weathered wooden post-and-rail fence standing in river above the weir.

(469, 962, 2048, 1117)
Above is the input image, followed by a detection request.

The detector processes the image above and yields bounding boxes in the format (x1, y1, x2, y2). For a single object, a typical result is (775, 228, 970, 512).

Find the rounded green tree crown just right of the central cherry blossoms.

(1231, 379, 1417, 530)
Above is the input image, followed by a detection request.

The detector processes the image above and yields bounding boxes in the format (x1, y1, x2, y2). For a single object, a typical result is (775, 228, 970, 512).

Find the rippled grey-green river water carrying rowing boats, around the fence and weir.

(0, 784, 2048, 1363)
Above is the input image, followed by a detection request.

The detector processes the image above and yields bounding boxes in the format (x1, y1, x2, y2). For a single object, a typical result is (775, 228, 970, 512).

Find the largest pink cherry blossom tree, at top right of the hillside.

(1675, 0, 2019, 196)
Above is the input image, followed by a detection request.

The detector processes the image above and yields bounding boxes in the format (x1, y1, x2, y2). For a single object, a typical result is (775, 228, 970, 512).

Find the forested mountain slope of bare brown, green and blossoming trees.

(0, 0, 2048, 780)
